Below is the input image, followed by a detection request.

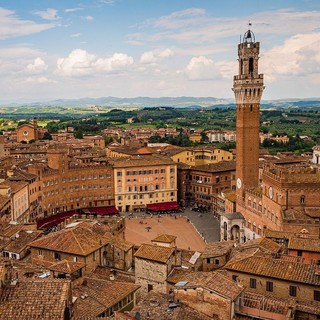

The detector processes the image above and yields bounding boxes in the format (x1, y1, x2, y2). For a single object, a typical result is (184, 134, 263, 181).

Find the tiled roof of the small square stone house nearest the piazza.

(134, 244, 175, 263)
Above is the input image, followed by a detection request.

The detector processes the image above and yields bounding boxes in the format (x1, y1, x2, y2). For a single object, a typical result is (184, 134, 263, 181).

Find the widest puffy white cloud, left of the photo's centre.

(57, 49, 133, 76)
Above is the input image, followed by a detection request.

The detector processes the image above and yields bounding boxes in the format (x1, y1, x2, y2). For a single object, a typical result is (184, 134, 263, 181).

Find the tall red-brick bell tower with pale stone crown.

(233, 27, 264, 203)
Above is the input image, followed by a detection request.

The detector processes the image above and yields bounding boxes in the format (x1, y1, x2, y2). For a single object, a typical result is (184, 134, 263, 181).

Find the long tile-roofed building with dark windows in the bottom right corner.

(224, 255, 320, 319)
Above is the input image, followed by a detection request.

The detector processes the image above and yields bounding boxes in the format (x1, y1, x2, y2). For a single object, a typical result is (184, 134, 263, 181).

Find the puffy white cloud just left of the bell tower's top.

(184, 56, 220, 80)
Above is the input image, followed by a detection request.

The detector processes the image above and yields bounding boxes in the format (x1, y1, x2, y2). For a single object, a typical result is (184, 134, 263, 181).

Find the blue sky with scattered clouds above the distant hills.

(0, 0, 320, 102)
